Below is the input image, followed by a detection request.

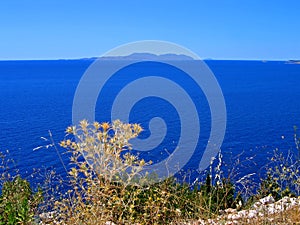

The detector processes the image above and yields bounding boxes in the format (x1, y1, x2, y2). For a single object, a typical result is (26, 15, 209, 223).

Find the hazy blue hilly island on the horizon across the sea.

(84, 53, 194, 61)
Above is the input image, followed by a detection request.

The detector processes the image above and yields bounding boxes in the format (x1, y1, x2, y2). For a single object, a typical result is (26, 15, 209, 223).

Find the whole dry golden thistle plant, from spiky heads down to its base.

(55, 120, 155, 224)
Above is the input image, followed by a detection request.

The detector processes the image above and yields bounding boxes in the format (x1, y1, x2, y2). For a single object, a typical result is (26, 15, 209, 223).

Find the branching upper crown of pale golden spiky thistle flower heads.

(60, 120, 146, 183)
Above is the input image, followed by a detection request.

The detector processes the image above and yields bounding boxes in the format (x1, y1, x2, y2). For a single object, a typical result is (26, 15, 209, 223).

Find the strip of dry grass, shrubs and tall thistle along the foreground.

(0, 120, 300, 224)
